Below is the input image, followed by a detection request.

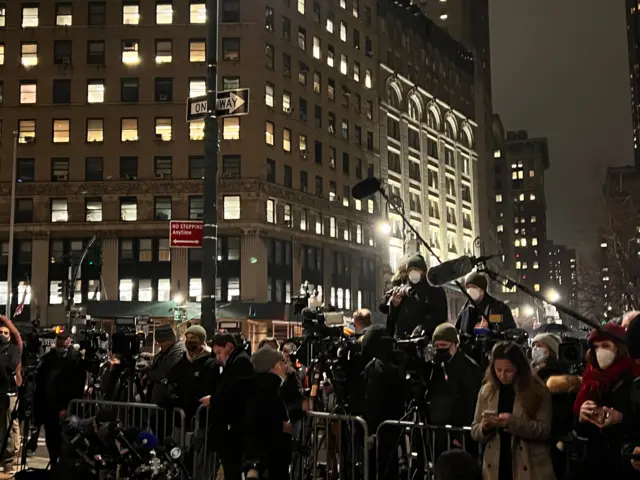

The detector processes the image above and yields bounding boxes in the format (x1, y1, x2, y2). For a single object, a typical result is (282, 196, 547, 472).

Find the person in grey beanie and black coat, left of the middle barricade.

(245, 346, 293, 479)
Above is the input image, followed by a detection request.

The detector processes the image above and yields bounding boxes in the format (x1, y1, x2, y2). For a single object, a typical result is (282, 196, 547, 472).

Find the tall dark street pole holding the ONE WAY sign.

(200, 0, 219, 337)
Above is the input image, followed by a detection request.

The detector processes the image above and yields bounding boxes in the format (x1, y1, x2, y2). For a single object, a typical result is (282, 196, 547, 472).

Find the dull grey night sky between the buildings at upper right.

(490, 0, 633, 254)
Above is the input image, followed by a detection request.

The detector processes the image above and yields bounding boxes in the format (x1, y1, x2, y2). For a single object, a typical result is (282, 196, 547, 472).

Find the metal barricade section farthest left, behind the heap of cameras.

(68, 400, 187, 448)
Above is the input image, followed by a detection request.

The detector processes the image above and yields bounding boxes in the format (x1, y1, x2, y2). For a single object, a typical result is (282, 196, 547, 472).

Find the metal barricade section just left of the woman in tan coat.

(373, 420, 478, 480)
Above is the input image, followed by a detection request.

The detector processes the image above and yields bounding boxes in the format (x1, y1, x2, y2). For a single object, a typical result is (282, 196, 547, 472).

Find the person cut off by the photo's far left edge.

(0, 316, 22, 474)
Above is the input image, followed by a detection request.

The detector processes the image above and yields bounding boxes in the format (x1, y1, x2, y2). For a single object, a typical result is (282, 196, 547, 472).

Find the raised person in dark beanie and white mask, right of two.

(456, 272, 516, 335)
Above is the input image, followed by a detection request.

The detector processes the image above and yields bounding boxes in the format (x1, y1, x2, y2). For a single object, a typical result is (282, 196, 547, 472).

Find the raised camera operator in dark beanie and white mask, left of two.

(387, 253, 447, 337)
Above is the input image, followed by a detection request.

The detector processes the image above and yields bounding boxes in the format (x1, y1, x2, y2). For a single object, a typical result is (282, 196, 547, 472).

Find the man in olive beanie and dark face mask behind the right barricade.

(426, 323, 483, 454)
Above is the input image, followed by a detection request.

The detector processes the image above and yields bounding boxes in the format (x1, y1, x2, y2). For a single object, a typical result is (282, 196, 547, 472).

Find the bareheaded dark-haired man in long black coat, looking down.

(200, 333, 254, 480)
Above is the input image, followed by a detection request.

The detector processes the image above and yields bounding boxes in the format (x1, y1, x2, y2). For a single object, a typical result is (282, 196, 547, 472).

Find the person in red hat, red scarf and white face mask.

(573, 323, 640, 480)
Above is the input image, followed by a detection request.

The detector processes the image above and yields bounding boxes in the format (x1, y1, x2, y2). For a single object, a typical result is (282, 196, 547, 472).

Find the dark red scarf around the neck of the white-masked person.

(573, 357, 640, 416)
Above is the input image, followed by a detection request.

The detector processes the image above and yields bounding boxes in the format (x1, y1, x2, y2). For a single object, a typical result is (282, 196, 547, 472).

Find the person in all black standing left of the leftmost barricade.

(34, 332, 87, 469)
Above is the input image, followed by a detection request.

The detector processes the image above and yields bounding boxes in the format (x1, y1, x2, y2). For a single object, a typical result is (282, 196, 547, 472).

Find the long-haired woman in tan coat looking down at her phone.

(471, 342, 555, 480)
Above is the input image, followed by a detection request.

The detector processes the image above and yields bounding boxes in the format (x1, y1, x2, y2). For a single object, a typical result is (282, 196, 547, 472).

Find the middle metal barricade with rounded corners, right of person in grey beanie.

(291, 412, 371, 480)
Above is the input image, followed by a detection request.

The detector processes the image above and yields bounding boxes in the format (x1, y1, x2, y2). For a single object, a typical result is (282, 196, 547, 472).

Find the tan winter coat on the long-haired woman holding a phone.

(471, 385, 555, 480)
